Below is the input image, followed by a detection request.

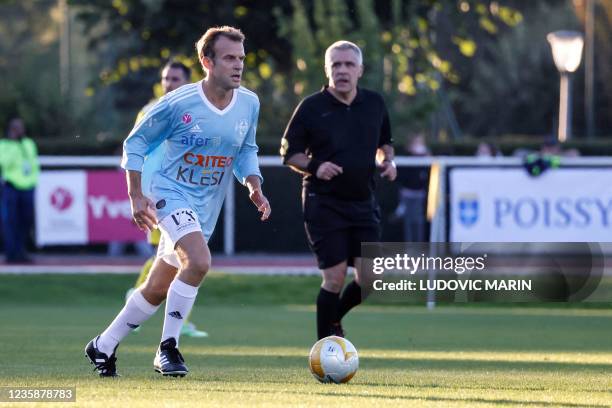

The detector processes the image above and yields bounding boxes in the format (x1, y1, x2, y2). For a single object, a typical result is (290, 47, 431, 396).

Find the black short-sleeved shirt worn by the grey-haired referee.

(281, 86, 392, 200)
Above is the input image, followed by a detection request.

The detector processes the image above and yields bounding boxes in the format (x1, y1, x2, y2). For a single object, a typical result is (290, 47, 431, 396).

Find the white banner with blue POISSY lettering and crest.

(449, 167, 612, 242)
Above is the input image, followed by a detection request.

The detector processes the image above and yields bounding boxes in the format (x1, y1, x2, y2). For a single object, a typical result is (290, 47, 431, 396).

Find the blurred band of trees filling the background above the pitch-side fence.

(0, 0, 612, 153)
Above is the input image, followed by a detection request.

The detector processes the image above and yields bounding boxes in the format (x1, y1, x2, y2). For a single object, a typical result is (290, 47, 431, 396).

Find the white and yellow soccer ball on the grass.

(308, 336, 359, 384)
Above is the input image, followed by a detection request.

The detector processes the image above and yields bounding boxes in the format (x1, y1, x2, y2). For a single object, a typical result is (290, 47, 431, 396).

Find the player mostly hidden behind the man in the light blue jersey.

(126, 60, 208, 338)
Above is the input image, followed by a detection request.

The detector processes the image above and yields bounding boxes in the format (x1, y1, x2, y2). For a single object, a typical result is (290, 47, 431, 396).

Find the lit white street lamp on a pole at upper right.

(546, 31, 584, 142)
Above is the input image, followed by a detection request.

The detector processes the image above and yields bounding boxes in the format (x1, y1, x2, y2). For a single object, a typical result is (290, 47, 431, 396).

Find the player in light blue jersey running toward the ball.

(85, 26, 271, 377)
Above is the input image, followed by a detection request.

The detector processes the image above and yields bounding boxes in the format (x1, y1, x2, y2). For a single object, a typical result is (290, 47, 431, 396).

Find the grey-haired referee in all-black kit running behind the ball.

(280, 41, 397, 339)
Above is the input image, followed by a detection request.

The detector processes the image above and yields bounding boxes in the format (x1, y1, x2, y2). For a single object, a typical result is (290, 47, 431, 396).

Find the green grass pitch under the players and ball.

(0, 274, 612, 407)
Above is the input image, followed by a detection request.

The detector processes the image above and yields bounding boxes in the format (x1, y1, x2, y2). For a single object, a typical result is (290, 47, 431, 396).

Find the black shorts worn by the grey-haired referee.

(302, 192, 380, 269)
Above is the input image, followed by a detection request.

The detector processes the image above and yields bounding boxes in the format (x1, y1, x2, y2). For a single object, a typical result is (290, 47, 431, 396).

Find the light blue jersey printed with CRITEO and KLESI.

(121, 81, 263, 240)
